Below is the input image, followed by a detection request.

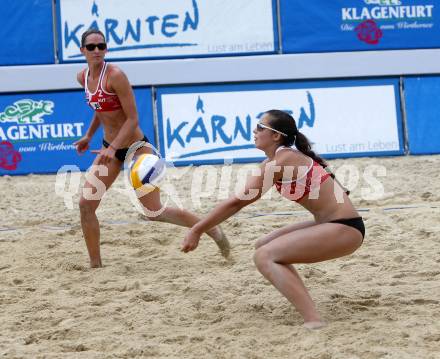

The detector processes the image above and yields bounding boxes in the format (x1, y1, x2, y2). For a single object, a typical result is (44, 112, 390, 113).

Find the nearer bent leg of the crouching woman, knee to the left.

(254, 223, 362, 327)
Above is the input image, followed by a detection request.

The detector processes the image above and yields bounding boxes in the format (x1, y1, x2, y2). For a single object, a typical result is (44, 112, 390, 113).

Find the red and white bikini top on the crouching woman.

(275, 147, 331, 202)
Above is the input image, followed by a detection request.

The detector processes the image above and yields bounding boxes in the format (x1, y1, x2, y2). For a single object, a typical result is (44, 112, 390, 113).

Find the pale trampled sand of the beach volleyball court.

(0, 156, 440, 359)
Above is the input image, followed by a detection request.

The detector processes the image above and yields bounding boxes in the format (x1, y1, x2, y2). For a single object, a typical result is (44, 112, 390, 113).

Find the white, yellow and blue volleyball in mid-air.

(129, 153, 166, 193)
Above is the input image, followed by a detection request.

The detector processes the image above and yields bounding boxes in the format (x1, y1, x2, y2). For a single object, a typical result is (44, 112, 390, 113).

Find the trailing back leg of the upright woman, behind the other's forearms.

(139, 189, 230, 257)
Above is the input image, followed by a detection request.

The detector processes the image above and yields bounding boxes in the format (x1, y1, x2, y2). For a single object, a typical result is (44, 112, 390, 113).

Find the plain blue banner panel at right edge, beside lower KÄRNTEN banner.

(404, 76, 440, 155)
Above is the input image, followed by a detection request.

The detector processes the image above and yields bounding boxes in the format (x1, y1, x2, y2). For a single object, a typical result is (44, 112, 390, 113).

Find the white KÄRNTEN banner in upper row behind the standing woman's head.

(57, 0, 278, 61)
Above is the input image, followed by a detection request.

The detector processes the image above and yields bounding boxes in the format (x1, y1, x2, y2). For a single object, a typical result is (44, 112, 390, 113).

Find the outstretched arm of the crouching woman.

(182, 160, 280, 253)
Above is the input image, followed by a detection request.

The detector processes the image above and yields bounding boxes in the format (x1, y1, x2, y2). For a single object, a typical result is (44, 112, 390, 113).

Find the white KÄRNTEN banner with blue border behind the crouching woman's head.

(157, 79, 403, 165)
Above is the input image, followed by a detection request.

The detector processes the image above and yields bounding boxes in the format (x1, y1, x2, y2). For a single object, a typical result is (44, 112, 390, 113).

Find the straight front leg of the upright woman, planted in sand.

(79, 157, 121, 268)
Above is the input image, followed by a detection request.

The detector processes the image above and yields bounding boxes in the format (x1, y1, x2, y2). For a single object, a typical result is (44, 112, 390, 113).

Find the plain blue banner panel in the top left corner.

(0, 0, 55, 65)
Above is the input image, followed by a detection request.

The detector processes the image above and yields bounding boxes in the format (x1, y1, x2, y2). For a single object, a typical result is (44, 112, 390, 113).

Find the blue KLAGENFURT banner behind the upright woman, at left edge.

(0, 88, 155, 175)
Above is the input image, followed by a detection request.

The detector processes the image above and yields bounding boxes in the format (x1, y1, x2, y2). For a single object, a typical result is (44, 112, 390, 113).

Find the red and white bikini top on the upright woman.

(84, 62, 122, 112)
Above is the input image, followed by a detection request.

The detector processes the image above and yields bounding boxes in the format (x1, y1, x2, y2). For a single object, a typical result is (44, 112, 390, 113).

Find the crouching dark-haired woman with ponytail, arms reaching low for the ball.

(182, 110, 365, 328)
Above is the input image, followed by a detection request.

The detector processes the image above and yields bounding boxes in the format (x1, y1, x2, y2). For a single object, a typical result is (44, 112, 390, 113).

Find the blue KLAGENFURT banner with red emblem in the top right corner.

(280, 0, 440, 53)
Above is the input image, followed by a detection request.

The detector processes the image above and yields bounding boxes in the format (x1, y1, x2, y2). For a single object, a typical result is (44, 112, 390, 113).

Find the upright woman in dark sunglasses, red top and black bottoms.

(75, 29, 229, 268)
